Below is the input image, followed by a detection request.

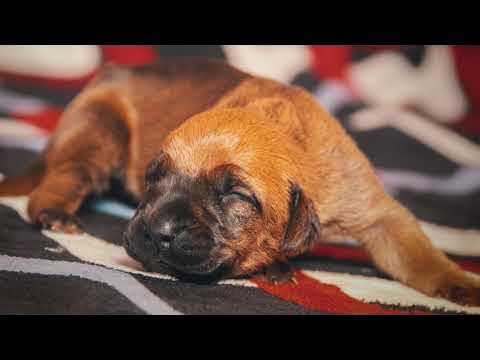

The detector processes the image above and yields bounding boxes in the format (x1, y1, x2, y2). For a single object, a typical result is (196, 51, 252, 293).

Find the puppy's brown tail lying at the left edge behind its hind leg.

(0, 159, 46, 197)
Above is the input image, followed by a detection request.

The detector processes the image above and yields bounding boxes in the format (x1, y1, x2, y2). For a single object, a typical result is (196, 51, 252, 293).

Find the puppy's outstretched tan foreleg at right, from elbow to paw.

(355, 198, 480, 305)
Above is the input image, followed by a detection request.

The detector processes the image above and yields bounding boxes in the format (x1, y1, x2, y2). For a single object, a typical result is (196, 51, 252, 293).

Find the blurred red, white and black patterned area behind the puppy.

(0, 45, 480, 229)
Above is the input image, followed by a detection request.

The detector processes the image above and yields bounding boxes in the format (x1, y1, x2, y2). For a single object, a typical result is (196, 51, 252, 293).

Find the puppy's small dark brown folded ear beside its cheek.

(283, 184, 320, 257)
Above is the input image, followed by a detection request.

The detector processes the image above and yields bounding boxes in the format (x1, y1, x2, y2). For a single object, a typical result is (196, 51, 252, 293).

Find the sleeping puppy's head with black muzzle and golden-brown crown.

(125, 105, 319, 279)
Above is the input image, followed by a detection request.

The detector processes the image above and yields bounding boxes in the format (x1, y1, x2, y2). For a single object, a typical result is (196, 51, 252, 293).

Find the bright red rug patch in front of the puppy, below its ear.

(252, 270, 431, 315)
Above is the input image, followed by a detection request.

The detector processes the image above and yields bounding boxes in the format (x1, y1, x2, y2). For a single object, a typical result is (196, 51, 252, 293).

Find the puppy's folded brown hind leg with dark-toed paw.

(28, 104, 128, 233)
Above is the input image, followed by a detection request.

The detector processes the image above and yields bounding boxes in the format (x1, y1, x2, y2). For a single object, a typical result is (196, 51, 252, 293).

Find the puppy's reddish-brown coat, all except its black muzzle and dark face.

(0, 58, 480, 305)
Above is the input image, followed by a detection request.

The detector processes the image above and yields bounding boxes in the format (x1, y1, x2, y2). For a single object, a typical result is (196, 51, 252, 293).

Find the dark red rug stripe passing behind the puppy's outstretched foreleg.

(310, 245, 480, 274)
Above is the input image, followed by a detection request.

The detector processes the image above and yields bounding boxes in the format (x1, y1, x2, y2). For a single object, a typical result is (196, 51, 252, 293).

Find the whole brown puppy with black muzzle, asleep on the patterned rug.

(0, 58, 480, 305)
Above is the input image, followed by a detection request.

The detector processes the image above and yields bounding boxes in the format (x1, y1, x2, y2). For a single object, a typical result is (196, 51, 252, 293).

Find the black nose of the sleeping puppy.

(146, 199, 195, 244)
